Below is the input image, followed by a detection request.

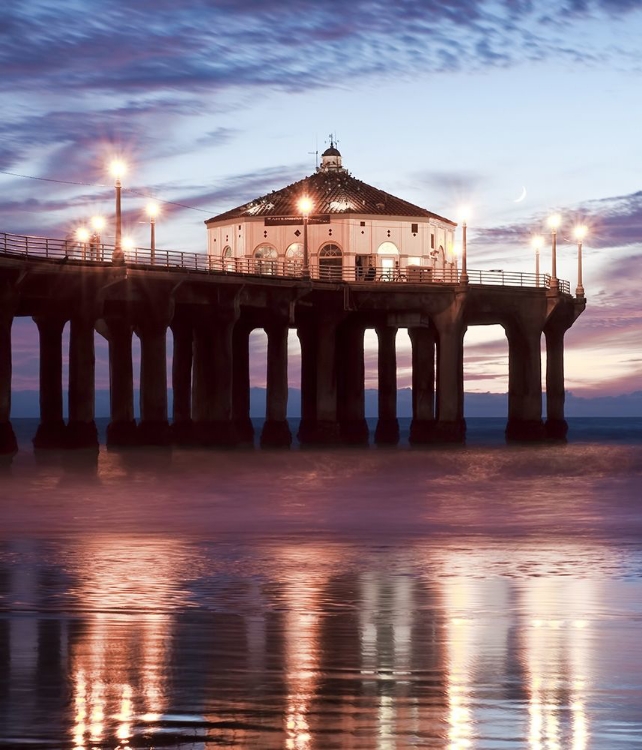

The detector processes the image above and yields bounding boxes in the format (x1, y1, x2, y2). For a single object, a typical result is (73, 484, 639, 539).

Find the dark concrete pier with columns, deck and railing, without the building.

(0, 229, 586, 453)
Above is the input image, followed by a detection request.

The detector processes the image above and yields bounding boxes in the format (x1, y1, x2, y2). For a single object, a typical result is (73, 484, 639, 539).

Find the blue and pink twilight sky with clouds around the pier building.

(0, 0, 642, 406)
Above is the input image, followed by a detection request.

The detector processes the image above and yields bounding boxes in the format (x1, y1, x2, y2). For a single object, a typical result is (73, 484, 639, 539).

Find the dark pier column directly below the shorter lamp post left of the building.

(136, 318, 171, 445)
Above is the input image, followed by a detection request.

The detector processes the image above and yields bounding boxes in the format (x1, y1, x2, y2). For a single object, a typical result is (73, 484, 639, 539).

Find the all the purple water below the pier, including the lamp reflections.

(0, 418, 642, 750)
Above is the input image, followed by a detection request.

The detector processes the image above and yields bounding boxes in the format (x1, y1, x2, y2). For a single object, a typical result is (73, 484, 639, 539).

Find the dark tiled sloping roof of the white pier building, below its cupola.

(205, 164, 456, 226)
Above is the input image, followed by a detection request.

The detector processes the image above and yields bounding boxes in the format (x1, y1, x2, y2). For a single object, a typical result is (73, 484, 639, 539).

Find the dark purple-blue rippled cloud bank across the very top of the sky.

(0, 0, 639, 103)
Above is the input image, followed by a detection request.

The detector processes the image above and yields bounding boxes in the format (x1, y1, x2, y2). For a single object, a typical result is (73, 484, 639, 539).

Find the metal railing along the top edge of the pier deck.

(0, 232, 571, 294)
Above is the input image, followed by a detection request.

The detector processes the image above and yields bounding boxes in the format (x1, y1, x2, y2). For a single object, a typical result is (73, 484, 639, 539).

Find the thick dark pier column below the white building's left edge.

(192, 311, 238, 446)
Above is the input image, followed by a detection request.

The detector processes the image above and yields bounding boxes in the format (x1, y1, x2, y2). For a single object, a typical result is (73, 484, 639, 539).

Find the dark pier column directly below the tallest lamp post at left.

(105, 318, 137, 446)
